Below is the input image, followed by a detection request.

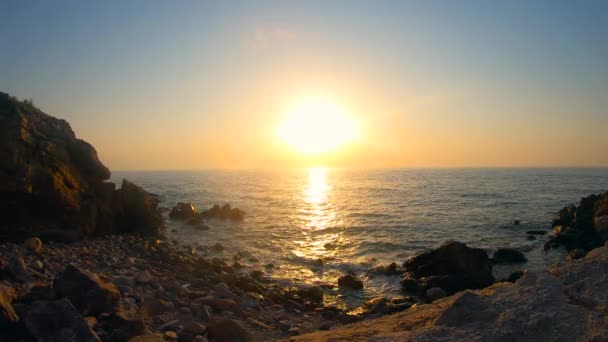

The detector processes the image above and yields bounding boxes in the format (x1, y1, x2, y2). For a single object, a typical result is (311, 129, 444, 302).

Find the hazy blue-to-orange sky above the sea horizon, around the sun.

(0, 0, 608, 170)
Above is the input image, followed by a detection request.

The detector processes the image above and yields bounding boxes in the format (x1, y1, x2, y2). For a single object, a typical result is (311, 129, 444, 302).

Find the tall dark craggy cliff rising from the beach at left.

(0, 93, 162, 241)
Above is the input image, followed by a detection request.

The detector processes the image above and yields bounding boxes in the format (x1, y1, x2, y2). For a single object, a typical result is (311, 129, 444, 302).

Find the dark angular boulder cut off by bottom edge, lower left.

(21, 298, 101, 342)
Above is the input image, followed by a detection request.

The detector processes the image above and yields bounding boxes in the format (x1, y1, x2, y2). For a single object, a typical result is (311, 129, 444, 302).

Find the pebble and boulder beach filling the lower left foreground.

(0, 236, 366, 341)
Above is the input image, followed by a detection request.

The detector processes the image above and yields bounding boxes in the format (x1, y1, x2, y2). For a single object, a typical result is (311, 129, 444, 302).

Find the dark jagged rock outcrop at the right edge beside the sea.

(545, 192, 608, 251)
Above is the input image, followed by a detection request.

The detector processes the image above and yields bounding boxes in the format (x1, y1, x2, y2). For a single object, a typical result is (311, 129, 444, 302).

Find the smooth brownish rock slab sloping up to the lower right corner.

(291, 247, 608, 341)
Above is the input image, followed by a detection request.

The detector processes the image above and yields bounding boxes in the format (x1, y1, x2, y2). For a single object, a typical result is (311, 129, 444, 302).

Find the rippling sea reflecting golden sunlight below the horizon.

(112, 167, 608, 309)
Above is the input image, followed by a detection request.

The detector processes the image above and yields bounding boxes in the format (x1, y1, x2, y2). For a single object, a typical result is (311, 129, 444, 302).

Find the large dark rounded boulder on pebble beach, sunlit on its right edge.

(53, 265, 120, 316)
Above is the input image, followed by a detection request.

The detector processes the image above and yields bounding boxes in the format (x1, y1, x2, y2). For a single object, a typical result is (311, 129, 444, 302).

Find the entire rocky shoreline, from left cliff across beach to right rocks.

(0, 93, 608, 342)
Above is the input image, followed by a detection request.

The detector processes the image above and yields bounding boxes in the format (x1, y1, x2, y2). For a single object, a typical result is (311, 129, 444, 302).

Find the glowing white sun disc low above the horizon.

(278, 99, 357, 155)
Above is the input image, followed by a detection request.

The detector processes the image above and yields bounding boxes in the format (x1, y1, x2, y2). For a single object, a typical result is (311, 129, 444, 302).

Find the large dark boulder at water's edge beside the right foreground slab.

(402, 241, 494, 295)
